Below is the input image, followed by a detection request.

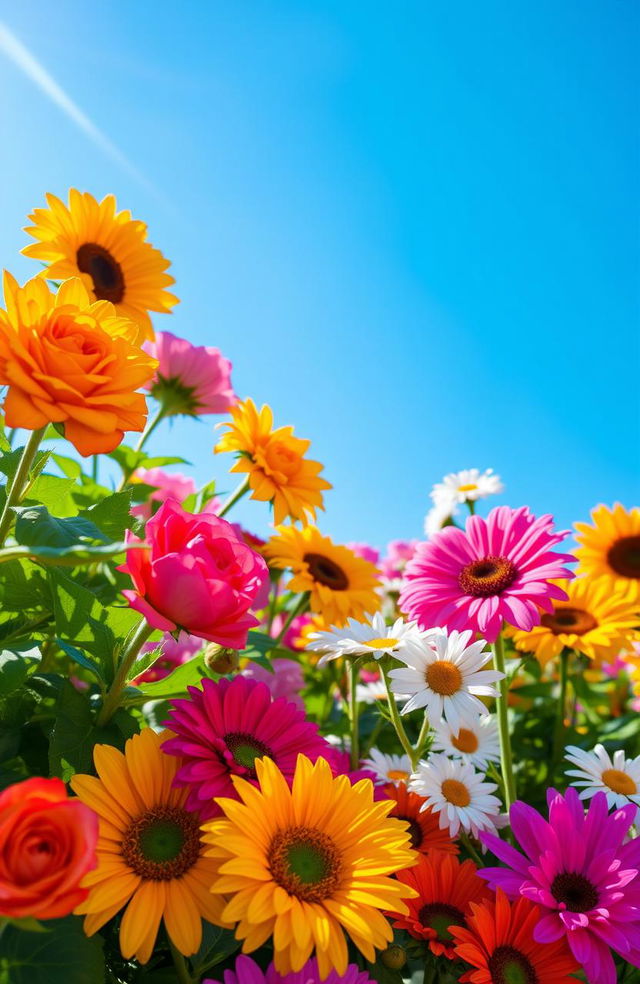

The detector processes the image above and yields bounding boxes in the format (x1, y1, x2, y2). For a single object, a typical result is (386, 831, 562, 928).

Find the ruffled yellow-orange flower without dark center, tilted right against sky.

(214, 399, 332, 526)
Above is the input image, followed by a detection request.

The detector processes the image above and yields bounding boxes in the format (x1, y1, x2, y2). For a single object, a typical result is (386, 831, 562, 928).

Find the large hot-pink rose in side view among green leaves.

(118, 499, 268, 649)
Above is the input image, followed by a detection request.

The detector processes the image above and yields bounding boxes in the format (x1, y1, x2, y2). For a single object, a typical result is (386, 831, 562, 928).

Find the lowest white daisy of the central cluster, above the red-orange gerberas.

(409, 755, 500, 837)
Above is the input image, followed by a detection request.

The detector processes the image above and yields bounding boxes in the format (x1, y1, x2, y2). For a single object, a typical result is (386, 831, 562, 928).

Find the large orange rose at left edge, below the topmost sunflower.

(0, 271, 158, 457)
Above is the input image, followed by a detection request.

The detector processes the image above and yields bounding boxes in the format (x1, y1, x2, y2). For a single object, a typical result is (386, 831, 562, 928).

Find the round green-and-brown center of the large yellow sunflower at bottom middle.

(267, 826, 342, 902)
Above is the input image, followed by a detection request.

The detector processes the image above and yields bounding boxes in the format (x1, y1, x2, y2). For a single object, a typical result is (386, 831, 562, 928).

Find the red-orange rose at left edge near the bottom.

(0, 778, 98, 919)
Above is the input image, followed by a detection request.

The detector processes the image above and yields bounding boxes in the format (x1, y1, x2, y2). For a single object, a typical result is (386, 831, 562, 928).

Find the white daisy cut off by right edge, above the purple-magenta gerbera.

(565, 744, 640, 822)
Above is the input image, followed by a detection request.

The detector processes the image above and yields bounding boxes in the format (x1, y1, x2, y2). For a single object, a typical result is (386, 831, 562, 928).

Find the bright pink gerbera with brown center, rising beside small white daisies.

(399, 506, 575, 642)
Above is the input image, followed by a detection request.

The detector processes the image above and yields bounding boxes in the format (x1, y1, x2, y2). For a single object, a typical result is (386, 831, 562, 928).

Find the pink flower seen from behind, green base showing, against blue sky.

(143, 331, 236, 417)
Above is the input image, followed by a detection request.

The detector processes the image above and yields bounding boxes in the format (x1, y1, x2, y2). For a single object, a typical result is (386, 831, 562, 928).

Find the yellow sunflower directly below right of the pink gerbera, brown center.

(506, 577, 640, 666)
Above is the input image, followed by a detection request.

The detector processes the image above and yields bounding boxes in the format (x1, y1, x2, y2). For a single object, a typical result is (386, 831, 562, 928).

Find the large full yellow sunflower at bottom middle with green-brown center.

(203, 755, 418, 979)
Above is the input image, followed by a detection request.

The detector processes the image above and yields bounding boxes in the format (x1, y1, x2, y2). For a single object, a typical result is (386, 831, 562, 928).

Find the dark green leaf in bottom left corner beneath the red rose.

(0, 916, 105, 984)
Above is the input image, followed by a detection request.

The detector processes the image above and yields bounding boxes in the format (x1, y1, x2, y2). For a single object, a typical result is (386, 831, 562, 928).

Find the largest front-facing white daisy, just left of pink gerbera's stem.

(389, 629, 504, 731)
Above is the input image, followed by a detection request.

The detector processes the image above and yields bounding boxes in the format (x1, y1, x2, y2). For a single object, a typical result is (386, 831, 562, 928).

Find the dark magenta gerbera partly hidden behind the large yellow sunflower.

(162, 676, 334, 820)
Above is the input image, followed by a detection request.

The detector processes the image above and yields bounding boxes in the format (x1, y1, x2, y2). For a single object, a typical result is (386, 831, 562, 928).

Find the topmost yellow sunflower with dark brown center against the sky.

(22, 188, 178, 341)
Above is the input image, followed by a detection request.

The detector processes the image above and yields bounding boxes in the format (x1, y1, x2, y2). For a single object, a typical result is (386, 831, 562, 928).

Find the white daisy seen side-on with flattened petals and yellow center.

(306, 612, 424, 667)
